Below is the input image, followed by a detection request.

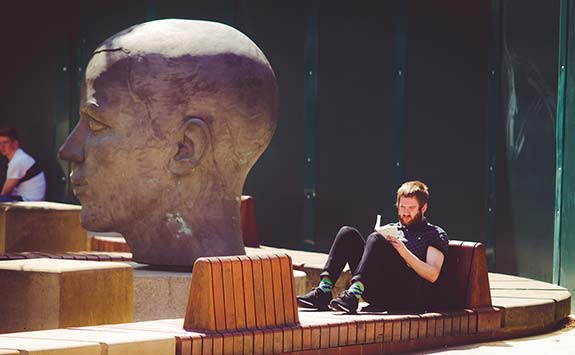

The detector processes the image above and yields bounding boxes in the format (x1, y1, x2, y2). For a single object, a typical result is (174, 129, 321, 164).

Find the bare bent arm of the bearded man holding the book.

(384, 236, 445, 283)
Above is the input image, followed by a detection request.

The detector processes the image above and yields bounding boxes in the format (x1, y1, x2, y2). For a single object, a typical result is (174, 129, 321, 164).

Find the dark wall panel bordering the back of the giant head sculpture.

(235, 0, 306, 248)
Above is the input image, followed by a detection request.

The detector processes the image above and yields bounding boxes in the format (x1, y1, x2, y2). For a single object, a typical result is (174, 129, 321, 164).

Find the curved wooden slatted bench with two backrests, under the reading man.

(176, 241, 501, 355)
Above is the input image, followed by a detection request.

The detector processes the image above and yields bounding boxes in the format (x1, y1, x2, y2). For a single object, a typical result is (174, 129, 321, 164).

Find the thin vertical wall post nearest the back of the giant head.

(302, 0, 319, 250)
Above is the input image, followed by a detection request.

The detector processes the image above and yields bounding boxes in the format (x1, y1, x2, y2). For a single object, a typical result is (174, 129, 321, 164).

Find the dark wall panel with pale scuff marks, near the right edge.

(496, 0, 559, 281)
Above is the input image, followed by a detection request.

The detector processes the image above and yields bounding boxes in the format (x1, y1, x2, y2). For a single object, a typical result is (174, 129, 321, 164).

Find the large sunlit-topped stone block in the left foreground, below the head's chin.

(0, 259, 133, 334)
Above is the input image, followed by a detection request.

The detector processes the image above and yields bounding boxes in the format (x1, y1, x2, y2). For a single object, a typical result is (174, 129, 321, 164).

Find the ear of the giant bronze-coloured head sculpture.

(168, 117, 210, 175)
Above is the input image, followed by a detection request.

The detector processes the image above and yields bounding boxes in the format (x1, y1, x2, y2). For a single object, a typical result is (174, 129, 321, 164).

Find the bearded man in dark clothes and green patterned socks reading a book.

(298, 181, 449, 313)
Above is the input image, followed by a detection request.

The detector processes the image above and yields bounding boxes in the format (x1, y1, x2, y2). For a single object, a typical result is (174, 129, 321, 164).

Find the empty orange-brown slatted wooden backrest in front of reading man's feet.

(184, 254, 299, 332)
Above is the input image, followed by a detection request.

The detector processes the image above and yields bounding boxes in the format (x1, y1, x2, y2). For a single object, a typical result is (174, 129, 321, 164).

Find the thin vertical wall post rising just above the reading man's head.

(392, 0, 408, 211)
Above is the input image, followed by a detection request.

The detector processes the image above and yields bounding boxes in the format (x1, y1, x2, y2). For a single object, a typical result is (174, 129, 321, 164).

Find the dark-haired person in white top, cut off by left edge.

(0, 128, 46, 202)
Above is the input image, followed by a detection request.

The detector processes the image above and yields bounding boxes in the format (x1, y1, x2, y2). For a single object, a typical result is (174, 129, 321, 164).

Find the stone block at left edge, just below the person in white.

(0, 201, 88, 254)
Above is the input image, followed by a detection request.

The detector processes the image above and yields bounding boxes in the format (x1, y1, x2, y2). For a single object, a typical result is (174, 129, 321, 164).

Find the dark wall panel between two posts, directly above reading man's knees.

(316, 1, 395, 251)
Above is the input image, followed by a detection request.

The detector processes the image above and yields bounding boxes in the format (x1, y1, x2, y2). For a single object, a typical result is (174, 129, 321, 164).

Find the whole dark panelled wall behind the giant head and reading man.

(0, 0, 559, 280)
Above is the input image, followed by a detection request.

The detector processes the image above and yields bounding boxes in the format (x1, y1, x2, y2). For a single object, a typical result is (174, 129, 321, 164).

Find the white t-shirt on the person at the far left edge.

(6, 148, 46, 201)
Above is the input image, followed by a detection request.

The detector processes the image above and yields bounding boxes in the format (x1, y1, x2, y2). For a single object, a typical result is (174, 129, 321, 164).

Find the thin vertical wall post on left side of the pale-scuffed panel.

(485, 0, 503, 270)
